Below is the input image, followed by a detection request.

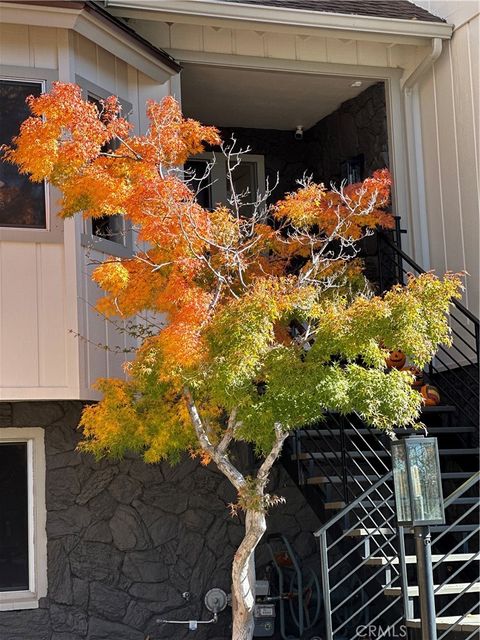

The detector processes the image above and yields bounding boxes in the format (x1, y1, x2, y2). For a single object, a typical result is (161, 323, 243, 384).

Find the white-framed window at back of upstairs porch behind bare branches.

(185, 153, 265, 216)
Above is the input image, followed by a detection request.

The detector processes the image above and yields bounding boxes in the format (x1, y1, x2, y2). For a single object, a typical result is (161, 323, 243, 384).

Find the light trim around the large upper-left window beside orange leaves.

(0, 65, 63, 242)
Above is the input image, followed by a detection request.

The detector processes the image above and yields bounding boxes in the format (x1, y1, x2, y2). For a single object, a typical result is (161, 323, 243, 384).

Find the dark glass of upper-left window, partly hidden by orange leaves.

(0, 80, 46, 229)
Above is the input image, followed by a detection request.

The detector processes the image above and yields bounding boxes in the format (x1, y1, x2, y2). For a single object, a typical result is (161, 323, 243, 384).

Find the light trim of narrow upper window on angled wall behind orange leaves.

(75, 75, 133, 258)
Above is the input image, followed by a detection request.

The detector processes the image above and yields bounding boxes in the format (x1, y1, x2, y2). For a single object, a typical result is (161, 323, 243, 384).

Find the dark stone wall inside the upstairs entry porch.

(222, 82, 389, 202)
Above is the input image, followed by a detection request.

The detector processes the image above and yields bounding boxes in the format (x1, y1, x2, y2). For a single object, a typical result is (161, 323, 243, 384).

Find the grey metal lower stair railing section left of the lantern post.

(315, 471, 405, 640)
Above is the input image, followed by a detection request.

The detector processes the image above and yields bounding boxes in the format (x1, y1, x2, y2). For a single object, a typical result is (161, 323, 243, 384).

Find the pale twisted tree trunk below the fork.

(232, 510, 267, 640)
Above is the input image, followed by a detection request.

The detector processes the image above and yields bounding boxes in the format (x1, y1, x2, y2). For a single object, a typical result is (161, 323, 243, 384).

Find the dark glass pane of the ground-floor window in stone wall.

(0, 442, 29, 591)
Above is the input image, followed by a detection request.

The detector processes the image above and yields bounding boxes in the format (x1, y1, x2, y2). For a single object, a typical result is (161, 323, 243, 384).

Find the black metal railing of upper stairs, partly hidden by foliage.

(377, 229, 480, 440)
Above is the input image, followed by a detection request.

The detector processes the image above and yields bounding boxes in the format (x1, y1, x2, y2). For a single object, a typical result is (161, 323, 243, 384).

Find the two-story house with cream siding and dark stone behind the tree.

(0, 0, 479, 640)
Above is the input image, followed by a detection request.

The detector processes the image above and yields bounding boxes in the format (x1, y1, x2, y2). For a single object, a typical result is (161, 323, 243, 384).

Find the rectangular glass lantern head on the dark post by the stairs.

(392, 436, 445, 527)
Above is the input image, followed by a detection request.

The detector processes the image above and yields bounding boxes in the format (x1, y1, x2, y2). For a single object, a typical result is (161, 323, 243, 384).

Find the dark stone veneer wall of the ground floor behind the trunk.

(0, 402, 318, 640)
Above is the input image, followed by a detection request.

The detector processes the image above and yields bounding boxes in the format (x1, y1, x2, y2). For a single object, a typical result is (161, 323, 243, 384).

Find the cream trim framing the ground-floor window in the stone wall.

(0, 427, 48, 611)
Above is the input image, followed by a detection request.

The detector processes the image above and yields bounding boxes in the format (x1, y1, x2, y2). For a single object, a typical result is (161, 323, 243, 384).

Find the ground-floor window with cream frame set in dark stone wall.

(0, 428, 47, 610)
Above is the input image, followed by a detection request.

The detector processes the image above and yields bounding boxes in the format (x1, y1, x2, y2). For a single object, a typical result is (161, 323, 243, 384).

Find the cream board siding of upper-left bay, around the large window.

(0, 24, 176, 400)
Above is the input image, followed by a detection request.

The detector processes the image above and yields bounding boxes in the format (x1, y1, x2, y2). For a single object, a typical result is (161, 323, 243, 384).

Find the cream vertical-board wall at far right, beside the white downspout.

(417, 1, 480, 316)
